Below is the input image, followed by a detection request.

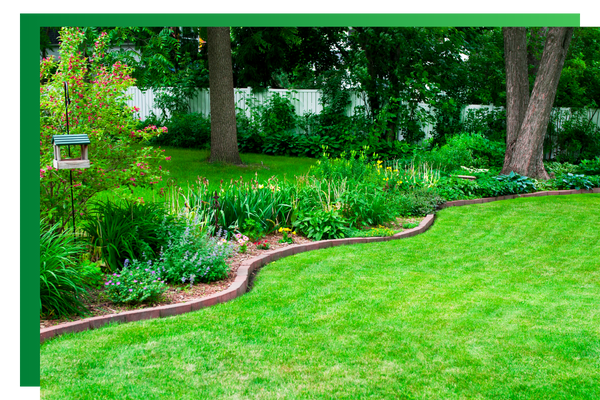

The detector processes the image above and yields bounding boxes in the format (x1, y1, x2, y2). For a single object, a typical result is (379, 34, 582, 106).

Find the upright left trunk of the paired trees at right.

(502, 28, 529, 174)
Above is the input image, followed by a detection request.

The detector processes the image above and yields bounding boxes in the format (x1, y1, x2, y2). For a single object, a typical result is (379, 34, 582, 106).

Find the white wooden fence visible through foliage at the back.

(126, 87, 600, 143)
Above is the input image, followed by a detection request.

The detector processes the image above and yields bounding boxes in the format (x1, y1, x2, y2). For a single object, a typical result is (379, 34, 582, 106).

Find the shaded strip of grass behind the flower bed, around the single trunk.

(98, 145, 317, 201)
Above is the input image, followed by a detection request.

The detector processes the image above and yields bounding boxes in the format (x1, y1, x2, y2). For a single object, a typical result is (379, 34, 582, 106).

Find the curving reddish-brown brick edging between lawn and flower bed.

(40, 188, 600, 343)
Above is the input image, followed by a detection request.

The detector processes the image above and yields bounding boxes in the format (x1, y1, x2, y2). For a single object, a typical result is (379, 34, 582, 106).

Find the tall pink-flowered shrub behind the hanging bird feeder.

(40, 27, 171, 230)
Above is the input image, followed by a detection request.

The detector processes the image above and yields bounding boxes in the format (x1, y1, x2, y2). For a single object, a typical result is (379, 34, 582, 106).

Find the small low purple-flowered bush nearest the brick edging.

(104, 260, 166, 303)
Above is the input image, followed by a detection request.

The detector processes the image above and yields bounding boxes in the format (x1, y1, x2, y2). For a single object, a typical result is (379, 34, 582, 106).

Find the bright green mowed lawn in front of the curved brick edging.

(38, 194, 600, 400)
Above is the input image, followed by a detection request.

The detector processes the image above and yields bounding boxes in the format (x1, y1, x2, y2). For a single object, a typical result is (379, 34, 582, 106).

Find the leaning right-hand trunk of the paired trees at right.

(502, 28, 574, 179)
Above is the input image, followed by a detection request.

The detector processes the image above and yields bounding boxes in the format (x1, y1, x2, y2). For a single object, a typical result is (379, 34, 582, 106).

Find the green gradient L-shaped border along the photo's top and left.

(17, 10, 583, 390)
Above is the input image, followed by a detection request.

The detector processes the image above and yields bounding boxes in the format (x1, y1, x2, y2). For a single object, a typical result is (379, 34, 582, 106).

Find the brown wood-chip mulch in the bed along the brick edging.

(40, 218, 423, 329)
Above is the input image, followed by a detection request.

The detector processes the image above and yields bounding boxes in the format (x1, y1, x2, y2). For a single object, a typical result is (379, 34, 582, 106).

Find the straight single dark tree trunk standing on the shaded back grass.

(206, 28, 242, 164)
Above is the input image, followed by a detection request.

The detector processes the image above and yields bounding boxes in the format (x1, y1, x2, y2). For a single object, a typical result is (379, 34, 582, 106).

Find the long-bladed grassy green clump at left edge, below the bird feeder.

(40, 220, 94, 318)
